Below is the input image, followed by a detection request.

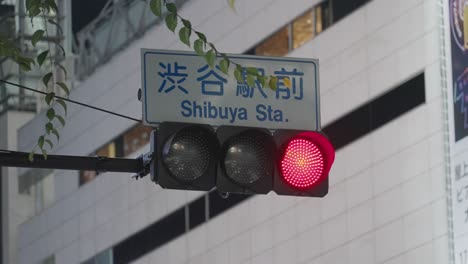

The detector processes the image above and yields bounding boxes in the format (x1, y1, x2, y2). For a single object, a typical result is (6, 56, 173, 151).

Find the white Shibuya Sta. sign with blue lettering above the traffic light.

(141, 49, 320, 130)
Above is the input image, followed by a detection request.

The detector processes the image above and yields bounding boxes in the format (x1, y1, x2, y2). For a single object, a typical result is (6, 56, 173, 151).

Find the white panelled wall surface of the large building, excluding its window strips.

(19, 0, 448, 264)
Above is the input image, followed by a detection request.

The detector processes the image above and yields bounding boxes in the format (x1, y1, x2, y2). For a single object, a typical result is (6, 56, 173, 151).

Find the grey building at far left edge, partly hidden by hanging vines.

(0, 0, 71, 263)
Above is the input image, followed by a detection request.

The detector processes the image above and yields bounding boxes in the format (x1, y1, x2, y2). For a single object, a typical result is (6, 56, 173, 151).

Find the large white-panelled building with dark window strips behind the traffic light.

(9, 0, 468, 264)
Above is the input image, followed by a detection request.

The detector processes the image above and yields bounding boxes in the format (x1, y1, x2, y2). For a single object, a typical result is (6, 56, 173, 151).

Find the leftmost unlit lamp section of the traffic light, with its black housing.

(154, 123, 219, 191)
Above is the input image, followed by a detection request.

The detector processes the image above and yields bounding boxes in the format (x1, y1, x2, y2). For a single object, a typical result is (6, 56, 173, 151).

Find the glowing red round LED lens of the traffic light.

(280, 138, 325, 189)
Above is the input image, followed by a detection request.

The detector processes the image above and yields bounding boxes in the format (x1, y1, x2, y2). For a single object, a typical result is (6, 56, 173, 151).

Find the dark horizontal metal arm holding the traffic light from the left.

(0, 150, 144, 173)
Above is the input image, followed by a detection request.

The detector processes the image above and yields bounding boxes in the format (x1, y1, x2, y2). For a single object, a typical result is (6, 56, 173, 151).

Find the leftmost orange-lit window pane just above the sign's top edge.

(255, 27, 289, 56)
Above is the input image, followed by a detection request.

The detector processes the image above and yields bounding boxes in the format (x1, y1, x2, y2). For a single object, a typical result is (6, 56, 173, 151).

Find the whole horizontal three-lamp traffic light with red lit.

(151, 122, 335, 197)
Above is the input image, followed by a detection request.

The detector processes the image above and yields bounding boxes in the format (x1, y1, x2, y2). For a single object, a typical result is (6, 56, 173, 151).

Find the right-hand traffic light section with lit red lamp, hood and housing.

(273, 129, 335, 197)
